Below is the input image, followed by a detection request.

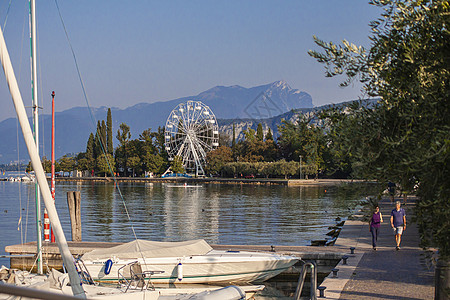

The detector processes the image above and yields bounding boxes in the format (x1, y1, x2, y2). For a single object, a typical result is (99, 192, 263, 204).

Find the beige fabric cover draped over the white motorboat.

(82, 240, 212, 261)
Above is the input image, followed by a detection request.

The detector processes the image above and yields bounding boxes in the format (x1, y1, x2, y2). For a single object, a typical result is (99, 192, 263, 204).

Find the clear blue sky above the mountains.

(0, 0, 379, 120)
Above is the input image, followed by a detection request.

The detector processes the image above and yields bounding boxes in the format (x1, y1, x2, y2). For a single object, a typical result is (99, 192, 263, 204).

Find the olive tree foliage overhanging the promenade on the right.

(309, 0, 450, 259)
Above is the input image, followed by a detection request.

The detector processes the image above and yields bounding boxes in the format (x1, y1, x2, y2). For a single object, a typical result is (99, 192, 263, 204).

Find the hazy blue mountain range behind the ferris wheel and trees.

(0, 81, 313, 163)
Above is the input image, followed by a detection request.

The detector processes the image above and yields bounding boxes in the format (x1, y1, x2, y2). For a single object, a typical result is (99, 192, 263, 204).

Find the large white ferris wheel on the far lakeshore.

(164, 101, 219, 176)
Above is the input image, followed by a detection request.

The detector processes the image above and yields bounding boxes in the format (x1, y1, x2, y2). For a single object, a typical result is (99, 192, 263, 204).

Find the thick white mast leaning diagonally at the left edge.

(0, 17, 86, 299)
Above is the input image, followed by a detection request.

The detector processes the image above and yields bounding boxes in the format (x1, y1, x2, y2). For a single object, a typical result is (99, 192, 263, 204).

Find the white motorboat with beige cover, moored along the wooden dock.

(81, 240, 299, 284)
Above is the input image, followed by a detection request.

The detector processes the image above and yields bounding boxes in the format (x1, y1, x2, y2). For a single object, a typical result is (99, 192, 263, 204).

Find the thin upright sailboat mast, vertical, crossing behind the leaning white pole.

(30, 0, 44, 274)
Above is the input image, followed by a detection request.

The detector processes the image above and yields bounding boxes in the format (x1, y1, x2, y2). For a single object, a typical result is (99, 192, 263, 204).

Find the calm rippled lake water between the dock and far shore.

(0, 181, 375, 266)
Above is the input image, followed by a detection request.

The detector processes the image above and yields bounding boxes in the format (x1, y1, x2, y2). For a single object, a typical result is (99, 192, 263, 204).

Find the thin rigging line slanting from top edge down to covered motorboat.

(55, 0, 145, 261)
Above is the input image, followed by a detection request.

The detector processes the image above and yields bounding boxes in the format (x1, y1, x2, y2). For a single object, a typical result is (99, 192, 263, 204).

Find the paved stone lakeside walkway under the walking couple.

(318, 198, 434, 300)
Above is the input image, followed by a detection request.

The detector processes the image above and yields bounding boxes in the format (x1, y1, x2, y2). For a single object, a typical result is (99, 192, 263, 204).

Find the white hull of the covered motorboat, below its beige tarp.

(83, 250, 299, 284)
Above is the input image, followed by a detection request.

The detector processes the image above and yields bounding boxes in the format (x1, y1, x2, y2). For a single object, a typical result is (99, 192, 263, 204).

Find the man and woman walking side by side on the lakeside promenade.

(369, 201, 406, 250)
